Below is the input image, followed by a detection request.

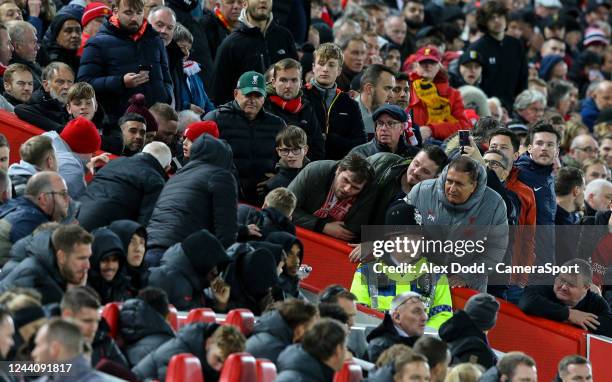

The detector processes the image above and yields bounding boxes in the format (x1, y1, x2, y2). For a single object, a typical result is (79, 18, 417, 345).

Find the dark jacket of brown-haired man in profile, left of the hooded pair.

(0, 234, 67, 305)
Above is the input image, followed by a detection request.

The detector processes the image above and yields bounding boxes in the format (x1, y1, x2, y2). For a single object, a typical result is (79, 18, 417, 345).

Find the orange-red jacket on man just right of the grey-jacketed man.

(506, 167, 537, 286)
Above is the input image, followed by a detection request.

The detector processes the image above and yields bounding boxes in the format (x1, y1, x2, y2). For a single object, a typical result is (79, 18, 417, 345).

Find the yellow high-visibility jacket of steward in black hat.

(351, 257, 453, 329)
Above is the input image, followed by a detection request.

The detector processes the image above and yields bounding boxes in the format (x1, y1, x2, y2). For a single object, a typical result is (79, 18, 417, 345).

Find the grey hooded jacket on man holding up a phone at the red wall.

(408, 165, 508, 291)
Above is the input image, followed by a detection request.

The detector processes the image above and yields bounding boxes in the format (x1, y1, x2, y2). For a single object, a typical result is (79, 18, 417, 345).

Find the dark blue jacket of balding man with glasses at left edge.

(0, 196, 51, 265)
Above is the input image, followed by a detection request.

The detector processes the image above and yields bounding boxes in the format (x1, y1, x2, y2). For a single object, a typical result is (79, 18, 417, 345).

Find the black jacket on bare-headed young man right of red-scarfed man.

(304, 84, 366, 160)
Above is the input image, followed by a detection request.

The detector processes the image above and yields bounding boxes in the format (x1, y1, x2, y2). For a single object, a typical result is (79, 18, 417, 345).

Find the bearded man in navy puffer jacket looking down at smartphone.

(77, 0, 172, 123)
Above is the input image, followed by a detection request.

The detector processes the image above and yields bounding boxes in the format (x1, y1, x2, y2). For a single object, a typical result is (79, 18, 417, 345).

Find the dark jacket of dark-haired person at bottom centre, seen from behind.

(275, 345, 334, 382)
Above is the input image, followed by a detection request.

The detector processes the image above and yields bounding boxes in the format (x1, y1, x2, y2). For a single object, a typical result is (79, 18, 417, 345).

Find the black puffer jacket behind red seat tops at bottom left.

(132, 323, 219, 381)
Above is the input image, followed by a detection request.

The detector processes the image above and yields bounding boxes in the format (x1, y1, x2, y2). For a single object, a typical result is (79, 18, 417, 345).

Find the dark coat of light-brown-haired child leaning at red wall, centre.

(238, 204, 295, 241)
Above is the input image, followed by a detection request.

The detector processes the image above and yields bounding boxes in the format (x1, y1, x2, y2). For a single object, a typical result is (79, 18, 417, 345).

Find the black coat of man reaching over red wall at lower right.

(518, 285, 612, 337)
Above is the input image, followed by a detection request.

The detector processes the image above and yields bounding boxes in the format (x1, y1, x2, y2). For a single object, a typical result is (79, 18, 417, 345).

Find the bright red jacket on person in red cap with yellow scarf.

(410, 71, 472, 140)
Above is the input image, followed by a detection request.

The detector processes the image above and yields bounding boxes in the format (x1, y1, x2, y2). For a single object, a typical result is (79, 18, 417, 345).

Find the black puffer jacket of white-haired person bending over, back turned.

(78, 153, 167, 230)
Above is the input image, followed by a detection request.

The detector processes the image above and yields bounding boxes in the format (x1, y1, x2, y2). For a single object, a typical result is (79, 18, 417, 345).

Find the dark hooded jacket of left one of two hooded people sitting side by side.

(87, 228, 130, 305)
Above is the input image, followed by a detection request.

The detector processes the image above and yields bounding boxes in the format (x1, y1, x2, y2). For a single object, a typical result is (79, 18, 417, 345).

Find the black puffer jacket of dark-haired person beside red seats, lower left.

(119, 298, 174, 366)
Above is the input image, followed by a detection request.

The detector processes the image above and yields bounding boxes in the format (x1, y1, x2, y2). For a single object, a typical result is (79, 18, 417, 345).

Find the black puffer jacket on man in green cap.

(202, 101, 286, 205)
